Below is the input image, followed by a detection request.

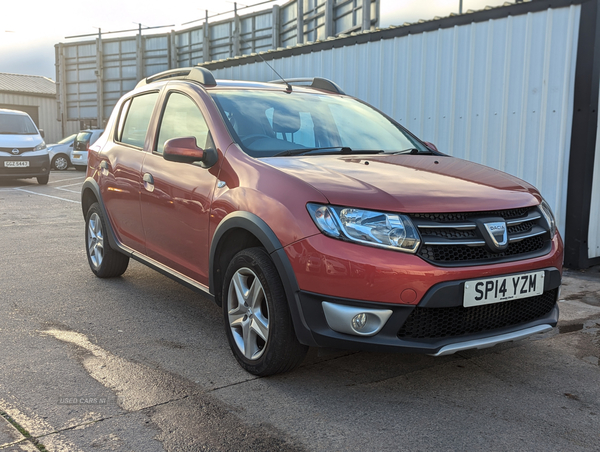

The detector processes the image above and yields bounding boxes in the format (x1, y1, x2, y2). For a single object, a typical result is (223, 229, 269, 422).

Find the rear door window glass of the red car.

(117, 93, 158, 148)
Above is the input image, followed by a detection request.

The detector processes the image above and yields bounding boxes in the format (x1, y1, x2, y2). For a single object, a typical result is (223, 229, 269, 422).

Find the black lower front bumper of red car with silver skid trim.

(299, 268, 561, 355)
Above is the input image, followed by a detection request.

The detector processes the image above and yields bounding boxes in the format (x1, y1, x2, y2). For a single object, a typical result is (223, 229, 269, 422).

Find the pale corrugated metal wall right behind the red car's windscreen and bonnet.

(213, 5, 581, 234)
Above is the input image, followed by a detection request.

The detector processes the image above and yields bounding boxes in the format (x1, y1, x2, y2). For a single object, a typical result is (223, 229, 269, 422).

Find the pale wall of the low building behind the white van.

(0, 93, 79, 144)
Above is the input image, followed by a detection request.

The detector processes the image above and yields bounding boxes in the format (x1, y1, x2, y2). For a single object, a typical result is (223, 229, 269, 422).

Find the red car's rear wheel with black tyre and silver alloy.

(85, 202, 129, 278)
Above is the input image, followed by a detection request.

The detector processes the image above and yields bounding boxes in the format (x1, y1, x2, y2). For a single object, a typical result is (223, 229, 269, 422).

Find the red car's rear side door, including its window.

(98, 91, 159, 253)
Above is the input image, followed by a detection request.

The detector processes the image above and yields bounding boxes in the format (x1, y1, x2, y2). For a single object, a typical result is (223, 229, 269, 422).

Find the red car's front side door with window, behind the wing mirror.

(141, 86, 219, 285)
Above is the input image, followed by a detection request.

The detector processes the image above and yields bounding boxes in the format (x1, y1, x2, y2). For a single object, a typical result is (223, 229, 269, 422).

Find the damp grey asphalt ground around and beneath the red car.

(0, 171, 600, 452)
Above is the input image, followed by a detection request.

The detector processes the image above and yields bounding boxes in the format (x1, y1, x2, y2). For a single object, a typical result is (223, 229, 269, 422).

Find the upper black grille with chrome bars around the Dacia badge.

(409, 207, 550, 266)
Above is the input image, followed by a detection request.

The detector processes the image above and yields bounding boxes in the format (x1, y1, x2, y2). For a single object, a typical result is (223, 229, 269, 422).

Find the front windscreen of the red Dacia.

(211, 90, 430, 157)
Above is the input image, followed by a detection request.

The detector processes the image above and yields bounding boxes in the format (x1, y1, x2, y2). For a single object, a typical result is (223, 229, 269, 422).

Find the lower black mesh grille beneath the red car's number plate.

(398, 289, 558, 340)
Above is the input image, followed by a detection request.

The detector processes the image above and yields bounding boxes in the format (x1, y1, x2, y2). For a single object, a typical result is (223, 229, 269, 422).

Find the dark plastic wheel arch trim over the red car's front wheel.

(208, 211, 317, 346)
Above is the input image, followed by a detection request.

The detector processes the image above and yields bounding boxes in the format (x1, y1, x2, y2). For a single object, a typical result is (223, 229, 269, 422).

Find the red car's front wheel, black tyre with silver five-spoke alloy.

(222, 248, 308, 376)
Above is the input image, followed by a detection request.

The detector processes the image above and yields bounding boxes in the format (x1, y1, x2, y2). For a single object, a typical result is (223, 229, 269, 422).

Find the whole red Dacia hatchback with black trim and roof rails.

(82, 67, 563, 375)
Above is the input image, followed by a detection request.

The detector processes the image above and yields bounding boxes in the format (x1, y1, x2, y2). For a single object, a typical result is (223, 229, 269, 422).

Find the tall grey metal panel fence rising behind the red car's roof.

(56, 0, 379, 125)
